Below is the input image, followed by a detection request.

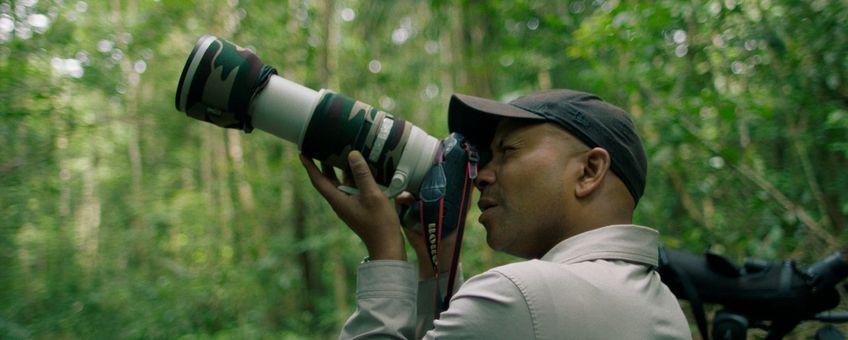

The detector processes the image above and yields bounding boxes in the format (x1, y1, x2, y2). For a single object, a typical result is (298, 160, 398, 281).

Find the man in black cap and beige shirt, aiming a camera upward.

(303, 90, 691, 339)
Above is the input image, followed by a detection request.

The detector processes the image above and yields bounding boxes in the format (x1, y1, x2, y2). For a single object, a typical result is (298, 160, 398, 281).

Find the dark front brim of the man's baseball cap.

(448, 94, 544, 149)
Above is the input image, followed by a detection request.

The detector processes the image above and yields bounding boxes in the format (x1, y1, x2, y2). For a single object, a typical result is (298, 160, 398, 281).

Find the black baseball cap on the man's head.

(448, 89, 648, 203)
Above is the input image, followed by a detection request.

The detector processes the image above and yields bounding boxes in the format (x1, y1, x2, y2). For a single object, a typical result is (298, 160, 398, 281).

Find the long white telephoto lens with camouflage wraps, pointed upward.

(176, 35, 439, 196)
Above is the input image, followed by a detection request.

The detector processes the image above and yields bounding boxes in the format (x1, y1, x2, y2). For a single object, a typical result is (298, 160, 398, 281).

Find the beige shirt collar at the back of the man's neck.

(541, 224, 659, 267)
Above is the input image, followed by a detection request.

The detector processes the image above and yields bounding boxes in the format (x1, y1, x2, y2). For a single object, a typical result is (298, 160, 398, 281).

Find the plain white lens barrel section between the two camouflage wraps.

(250, 75, 323, 147)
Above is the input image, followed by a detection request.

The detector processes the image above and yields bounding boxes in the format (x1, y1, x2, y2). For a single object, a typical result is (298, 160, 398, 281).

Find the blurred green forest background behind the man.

(0, 0, 848, 339)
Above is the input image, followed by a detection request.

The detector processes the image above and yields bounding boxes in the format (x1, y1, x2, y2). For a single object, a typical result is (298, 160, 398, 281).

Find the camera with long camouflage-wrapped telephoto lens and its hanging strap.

(175, 35, 479, 298)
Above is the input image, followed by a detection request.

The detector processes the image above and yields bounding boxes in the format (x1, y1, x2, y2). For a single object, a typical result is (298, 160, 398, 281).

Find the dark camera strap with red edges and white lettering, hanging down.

(418, 134, 479, 319)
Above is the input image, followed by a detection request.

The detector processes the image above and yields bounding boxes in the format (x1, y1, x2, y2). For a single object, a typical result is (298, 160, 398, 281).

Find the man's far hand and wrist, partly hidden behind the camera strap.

(395, 192, 456, 280)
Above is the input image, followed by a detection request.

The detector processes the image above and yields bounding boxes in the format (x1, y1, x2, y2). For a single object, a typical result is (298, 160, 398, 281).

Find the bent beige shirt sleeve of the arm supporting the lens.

(340, 261, 534, 339)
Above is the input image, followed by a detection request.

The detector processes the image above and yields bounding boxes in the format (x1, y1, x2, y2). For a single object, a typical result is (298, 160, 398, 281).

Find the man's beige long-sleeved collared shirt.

(341, 225, 691, 339)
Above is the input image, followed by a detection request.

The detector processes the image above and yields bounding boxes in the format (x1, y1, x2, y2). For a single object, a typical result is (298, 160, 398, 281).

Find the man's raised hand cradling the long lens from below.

(300, 151, 406, 260)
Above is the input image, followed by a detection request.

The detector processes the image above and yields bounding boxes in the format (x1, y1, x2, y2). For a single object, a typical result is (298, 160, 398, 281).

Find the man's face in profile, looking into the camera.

(477, 118, 589, 258)
